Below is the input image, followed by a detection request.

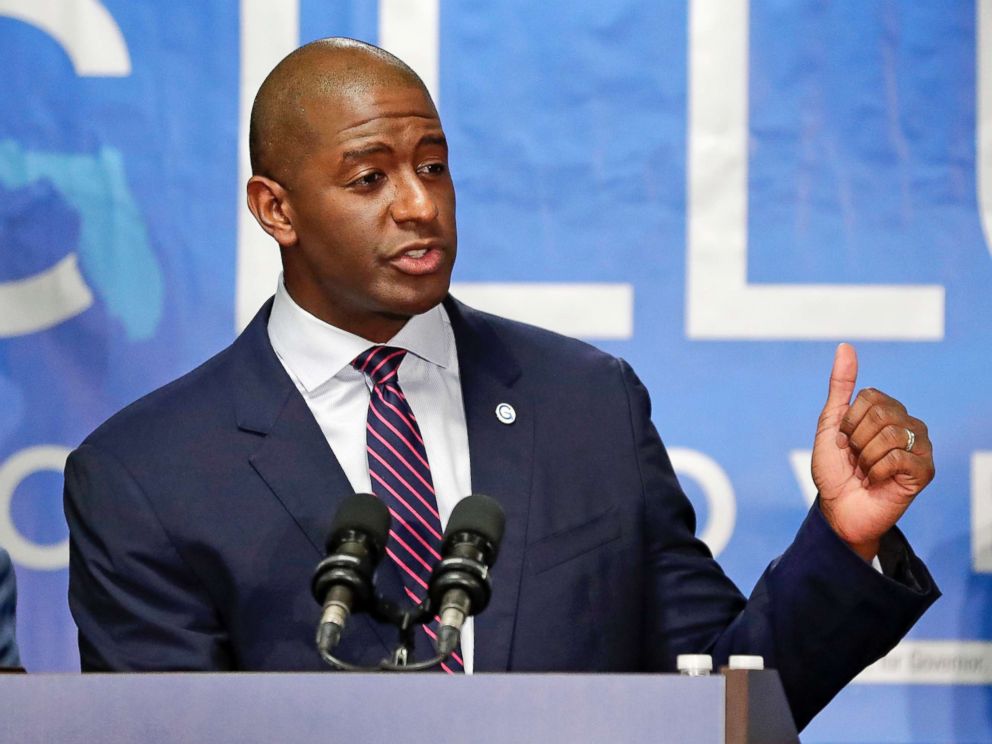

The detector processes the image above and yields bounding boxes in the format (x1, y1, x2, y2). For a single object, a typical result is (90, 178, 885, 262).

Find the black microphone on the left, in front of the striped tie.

(310, 493, 392, 652)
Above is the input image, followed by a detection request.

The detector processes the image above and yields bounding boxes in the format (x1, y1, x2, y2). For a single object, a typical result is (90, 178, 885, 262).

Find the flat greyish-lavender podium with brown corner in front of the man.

(0, 670, 799, 744)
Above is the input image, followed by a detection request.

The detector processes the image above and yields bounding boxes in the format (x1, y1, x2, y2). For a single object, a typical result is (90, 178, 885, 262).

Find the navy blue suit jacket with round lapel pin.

(65, 298, 937, 725)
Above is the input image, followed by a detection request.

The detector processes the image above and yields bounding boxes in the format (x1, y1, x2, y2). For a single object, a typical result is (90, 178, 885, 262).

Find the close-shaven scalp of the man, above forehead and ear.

(248, 38, 430, 185)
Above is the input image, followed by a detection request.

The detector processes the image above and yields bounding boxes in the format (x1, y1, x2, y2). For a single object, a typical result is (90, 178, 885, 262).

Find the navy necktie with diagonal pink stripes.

(351, 346, 464, 673)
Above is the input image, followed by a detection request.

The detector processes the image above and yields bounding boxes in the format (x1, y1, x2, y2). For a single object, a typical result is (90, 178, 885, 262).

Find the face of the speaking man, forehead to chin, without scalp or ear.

(282, 84, 457, 341)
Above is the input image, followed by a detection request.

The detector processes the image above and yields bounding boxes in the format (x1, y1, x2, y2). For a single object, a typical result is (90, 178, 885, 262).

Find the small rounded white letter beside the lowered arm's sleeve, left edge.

(0, 445, 69, 571)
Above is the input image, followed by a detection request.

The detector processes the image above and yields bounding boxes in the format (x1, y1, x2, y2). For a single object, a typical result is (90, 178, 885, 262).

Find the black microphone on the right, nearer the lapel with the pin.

(428, 494, 506, 656)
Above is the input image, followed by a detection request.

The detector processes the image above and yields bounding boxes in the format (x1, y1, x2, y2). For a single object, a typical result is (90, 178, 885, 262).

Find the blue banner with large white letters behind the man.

(0, 0, 992, 742)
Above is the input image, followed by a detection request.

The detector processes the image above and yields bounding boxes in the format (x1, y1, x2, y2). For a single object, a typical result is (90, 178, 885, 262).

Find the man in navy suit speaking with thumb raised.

(66, 39, 938, 726)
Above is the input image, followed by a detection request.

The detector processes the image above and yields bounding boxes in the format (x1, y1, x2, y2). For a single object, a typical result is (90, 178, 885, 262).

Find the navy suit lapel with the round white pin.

(445, 297, 534, 671)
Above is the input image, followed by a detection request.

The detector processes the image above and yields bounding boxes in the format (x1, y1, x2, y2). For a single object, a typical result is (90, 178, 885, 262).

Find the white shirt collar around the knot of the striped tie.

(268, 275, 454, 393)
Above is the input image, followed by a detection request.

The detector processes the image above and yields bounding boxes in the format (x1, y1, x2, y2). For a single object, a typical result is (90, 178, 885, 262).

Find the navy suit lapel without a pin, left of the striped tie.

(235, 300, 403, 653)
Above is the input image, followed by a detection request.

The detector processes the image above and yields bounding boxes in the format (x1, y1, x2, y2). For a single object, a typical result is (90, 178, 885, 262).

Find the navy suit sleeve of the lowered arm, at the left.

(65, 444, 233, 671)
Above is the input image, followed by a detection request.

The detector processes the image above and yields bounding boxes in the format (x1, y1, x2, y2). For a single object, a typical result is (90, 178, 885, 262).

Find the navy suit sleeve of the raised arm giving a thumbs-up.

(621, 362, 940, 729)
